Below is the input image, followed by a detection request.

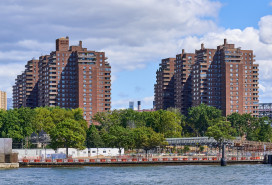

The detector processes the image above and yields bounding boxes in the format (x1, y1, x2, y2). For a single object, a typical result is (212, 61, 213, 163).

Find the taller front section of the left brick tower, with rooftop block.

(13, 37, 111, 124)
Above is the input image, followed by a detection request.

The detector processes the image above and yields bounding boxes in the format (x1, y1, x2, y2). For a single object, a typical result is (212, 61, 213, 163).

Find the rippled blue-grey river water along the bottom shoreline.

(0, 164, 272, 185)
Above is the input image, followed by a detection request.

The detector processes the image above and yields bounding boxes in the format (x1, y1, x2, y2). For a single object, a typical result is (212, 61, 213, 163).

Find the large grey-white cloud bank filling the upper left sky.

(0, 0, 221, 99)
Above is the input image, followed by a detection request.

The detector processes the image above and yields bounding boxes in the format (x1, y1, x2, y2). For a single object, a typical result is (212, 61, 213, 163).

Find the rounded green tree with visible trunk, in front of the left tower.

(50, 118, 87, 156)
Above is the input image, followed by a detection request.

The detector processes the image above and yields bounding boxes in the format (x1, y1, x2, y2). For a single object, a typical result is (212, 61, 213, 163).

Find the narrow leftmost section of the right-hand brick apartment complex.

(154, 58, 175, 110)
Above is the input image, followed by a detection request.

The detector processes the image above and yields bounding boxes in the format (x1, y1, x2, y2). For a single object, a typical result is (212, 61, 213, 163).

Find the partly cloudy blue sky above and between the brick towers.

(0, 0, 272, 109)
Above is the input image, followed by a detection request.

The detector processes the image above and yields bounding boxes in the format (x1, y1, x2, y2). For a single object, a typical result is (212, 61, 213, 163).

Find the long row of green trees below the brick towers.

(0, 104, 272, 150)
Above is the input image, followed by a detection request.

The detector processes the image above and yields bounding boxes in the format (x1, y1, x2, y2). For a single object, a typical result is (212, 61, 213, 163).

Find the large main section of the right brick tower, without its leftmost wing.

(155, 39, 259, 116)
